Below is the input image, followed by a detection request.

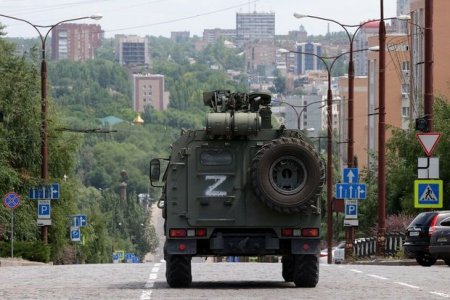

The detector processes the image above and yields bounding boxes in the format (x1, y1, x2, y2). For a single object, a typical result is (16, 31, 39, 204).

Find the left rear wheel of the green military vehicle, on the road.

(166, 255, 192, 288)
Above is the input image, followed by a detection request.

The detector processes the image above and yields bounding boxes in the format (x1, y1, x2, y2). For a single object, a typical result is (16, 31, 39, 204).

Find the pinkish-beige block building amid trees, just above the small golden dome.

(133, 74, 169, 112)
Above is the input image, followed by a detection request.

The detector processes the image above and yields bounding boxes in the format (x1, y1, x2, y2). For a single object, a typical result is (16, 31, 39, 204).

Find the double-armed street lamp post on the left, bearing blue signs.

(0, 14, 102, 243)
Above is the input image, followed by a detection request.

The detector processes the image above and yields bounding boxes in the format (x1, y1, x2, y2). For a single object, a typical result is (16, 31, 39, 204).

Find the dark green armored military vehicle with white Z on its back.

(150, 91, 325, 287)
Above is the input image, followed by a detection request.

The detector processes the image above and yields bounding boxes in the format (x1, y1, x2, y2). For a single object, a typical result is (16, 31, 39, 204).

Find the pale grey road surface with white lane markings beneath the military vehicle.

(0, 262, 450, 300)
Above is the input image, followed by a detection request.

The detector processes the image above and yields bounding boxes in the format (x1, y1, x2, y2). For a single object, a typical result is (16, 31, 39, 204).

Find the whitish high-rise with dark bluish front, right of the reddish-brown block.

(115, 35, 150, 65)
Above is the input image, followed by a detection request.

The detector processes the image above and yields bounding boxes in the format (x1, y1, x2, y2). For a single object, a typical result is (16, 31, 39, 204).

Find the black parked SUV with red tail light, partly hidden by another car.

(403, 211, 450, 267)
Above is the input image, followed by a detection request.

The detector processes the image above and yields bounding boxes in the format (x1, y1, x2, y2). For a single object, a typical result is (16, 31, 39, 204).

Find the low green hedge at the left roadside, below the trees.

(0, 241, 51, 263)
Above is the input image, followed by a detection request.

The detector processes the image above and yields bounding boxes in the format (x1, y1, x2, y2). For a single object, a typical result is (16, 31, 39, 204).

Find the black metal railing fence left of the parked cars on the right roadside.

(353, 232, 405, 258)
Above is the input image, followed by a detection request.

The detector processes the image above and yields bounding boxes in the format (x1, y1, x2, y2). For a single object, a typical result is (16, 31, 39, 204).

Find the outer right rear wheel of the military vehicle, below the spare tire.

(294, 254, 319, 287)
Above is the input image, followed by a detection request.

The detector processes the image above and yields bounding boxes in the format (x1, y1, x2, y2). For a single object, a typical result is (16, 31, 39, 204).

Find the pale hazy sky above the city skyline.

(0, 0, 397, 38)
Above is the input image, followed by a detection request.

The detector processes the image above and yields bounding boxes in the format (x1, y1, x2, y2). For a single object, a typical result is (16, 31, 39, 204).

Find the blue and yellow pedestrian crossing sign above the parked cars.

(414, 180, 444, 208)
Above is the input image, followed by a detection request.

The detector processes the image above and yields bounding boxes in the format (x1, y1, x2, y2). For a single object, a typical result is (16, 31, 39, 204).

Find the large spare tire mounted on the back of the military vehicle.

(250, 137, 325, 213)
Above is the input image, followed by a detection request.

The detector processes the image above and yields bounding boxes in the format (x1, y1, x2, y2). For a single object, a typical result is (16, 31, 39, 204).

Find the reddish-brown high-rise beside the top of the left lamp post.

(51, 23, 103, 61)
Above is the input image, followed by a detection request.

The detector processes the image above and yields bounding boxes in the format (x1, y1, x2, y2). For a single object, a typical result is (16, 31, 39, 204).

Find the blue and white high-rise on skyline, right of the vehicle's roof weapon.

(296, 42, 323, 74)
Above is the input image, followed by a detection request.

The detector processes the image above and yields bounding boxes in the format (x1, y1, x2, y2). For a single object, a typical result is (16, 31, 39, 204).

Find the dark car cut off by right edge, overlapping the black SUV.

(430, 217, 450, 267)
